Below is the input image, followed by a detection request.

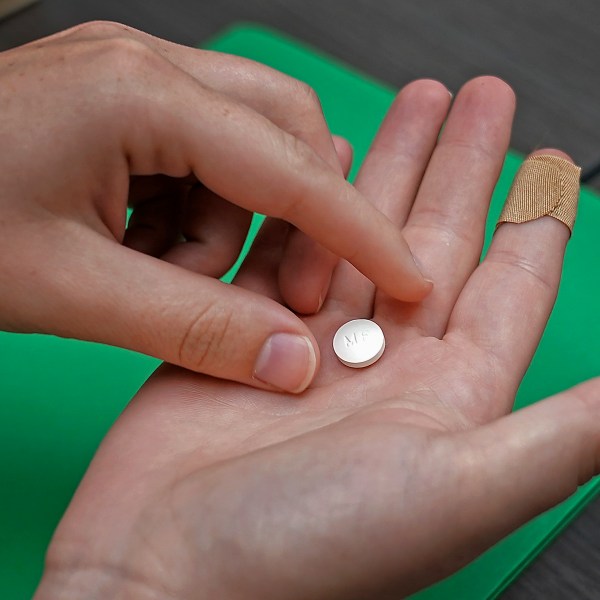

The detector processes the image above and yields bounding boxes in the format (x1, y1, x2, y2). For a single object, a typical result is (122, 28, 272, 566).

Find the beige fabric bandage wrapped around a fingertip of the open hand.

(496, 154, 581, 232)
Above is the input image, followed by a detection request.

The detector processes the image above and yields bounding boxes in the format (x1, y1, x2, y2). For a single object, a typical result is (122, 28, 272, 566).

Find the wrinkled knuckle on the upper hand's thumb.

(179, 303, 233, 374)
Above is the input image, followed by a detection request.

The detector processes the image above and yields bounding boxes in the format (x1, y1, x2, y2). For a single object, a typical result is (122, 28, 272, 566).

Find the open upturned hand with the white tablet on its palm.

(37, 78, 600, 600)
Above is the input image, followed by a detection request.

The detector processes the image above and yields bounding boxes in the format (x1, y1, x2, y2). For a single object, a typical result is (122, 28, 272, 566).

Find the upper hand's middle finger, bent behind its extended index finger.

(53, 22, 352, 313)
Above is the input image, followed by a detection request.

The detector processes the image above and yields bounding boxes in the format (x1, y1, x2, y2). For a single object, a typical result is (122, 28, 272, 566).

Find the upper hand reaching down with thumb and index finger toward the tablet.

(0, 23, 431, 391)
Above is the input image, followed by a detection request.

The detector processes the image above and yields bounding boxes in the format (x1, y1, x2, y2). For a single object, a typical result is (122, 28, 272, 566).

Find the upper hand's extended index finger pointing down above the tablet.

(113, 54, 431, 301)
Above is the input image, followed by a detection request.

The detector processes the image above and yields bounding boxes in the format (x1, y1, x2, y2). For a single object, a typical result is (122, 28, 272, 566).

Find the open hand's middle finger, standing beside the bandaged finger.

(375, 77, 515, 339)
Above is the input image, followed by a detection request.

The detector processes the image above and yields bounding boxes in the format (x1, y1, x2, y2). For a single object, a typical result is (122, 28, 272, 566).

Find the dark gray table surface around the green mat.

(0, 0, 600, 600)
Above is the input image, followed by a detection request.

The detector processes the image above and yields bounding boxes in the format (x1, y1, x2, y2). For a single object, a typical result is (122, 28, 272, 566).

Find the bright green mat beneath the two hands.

(0, 25, 600, 600)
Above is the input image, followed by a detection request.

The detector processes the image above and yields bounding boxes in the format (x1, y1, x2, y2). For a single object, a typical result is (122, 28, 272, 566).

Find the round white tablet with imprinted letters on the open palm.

(333, 319, 385, 369)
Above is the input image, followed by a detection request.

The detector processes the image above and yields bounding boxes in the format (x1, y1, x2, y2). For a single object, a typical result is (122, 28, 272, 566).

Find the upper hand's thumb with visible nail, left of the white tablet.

(17, 234, 319, 393)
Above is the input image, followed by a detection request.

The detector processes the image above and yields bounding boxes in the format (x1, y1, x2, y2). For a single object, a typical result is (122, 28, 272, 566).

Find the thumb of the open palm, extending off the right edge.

(450, 378, 600, 551)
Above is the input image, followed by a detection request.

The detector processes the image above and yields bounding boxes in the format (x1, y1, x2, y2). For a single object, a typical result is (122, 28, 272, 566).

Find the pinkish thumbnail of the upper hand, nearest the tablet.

(253, 333, 317, 394)
